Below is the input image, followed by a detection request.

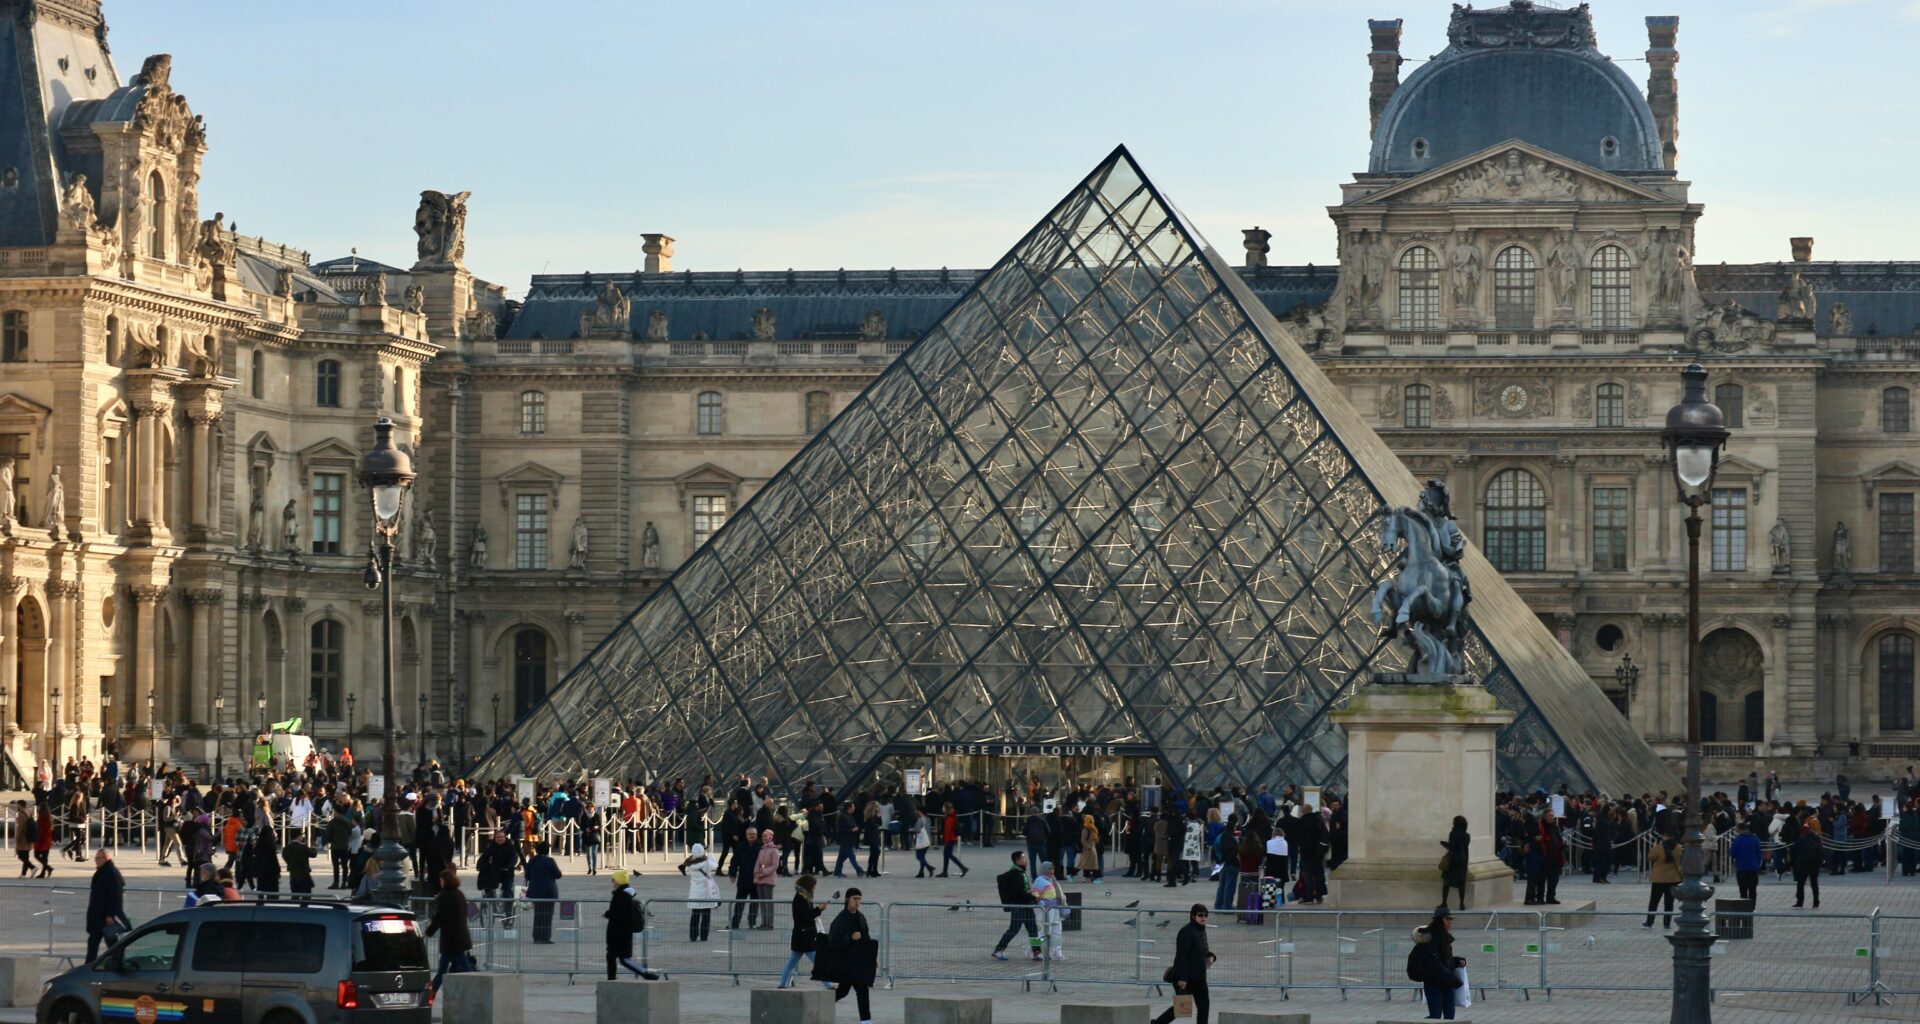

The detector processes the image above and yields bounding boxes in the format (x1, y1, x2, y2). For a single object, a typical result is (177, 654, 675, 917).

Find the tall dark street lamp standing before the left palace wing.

(361, 417, 413, 907)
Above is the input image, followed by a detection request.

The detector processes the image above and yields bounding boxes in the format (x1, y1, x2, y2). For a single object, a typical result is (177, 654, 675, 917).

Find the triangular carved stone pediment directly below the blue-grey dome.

(1356, 140, 1674, 206)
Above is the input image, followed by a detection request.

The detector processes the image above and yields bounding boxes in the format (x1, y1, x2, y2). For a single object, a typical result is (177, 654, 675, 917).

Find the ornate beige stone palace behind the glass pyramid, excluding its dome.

(0, 0, 1920, 776)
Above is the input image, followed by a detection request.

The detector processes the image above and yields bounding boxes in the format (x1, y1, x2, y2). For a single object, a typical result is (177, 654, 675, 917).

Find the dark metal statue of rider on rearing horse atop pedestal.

(1369, 480, 1473, 676)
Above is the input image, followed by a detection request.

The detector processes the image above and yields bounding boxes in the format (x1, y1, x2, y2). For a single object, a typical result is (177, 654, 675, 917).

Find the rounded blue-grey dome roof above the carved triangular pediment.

(1367, 12, 1663, 173)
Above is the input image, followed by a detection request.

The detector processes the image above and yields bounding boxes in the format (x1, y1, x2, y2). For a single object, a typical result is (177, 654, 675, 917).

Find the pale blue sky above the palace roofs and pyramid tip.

(106, 0, 1920, 294)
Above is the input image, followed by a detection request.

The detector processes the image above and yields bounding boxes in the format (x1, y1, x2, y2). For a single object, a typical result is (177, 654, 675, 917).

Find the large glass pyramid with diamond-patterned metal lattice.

(482, 148, 1657, 792)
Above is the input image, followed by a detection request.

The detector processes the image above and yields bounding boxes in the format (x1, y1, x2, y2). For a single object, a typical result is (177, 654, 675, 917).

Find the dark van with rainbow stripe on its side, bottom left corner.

(35, 901, 434, 1024)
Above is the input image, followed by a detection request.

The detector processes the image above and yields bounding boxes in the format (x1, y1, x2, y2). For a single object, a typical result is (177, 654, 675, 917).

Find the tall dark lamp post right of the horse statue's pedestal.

(1661, 363, 1728, 1024)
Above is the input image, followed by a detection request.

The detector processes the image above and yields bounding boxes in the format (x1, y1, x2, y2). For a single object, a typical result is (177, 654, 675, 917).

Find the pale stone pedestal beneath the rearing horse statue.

(1327, 674, 1513, 911)
